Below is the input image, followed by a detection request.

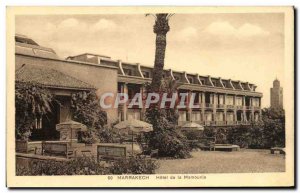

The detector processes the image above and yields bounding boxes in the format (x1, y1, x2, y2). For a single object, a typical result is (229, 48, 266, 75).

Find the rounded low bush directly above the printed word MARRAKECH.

(109, 157, 158, 175)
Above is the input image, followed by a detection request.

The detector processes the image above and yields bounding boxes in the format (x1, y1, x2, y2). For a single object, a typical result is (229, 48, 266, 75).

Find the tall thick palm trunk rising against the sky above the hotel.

(146, 13, 174, 92)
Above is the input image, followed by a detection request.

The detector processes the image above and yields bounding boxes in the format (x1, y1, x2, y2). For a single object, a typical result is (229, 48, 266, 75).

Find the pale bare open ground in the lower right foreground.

(156, 149, 285, 174)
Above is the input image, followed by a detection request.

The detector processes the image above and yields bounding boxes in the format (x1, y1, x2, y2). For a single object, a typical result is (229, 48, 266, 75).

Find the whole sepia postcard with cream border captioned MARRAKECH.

(6, 7, 294, 187)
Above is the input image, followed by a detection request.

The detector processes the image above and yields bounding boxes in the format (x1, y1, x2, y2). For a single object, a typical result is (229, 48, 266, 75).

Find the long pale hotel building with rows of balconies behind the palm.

(15, 35, 262, 130)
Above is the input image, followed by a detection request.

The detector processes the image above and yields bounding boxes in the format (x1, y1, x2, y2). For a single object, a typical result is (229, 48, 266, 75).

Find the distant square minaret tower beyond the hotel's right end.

(270, 79, 283, 109)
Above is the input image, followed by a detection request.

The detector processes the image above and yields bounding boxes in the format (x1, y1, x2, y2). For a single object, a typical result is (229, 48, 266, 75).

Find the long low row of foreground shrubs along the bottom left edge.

(16, 157, 158, 176)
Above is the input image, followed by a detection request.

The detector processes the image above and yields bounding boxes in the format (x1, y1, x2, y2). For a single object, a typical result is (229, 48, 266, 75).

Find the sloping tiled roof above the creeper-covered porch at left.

(16, 64, 94, 89)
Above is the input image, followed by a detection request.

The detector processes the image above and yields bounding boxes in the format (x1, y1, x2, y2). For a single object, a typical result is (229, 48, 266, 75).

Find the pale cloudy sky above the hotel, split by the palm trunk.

(15, 13, 284, 107)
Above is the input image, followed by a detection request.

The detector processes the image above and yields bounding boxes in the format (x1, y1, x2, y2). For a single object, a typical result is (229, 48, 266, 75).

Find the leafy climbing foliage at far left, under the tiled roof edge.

(15, 82, 57, 140)
